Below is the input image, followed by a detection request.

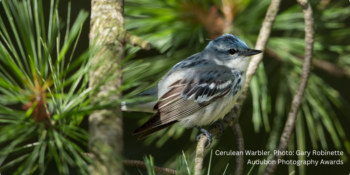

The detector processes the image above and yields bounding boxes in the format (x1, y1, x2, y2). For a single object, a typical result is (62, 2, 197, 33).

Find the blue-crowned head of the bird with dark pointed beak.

(204, 34, 262, 71)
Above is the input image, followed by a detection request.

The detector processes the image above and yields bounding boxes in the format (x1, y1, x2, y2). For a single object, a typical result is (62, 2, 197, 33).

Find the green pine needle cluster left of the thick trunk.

(0, 0, 91, 174)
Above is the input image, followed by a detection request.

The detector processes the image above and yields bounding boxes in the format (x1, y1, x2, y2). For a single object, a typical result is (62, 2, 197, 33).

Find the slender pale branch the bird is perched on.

(195, 0, 281, 172)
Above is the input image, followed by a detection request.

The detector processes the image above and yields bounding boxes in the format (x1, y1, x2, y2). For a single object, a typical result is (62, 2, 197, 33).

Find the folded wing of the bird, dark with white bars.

(133, 66, 242, 134)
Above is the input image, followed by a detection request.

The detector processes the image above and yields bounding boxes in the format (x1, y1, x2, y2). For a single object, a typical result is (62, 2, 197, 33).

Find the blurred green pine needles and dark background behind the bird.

(0, 0, 350, 174)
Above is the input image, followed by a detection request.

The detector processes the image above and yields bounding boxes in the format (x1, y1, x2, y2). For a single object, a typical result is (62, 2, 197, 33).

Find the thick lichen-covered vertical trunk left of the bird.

(89, 0, 124, 175)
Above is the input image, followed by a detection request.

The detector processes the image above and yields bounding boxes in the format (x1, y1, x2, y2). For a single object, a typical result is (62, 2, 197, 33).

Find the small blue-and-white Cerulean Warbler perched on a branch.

(122, 34, 262, 147)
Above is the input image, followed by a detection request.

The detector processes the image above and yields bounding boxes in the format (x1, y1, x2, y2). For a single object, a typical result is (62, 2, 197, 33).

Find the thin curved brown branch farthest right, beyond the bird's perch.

(264, 0, 314, 175)
